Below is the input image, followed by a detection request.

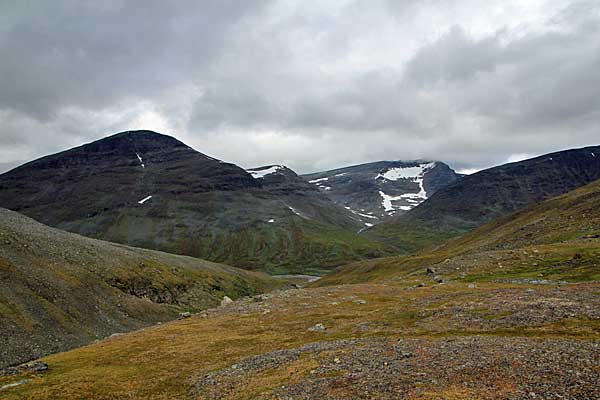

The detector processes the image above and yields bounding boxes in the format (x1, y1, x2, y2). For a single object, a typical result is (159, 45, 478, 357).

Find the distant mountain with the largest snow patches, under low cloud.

(303, 160, 460, 226)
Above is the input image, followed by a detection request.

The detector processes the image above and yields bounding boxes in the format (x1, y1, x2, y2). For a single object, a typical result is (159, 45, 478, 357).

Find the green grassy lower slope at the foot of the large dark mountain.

(172, 216, 394, 275)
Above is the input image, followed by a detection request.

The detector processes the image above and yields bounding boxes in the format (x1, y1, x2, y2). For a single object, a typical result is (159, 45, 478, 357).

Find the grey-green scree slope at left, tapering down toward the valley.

(0, 208, 279, 368)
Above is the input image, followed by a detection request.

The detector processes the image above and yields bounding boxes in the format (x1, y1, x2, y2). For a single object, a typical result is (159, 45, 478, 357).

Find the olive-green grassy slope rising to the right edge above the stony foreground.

(317, 177, 600, 285)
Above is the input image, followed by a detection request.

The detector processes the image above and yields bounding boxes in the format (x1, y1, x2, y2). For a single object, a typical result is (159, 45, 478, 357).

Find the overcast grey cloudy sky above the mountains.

(0, 0, 600, 172)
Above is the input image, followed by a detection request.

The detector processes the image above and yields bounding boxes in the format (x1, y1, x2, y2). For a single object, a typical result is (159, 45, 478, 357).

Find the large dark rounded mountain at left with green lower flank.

(0, 131, 390, 273)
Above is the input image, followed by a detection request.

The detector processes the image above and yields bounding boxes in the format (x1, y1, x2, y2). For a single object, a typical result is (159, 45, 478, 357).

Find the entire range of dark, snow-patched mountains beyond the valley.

(0, 131, 600, 274)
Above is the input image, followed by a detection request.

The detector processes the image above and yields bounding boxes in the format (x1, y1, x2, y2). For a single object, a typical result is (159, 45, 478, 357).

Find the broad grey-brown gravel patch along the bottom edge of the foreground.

(195, 336, 600, 400)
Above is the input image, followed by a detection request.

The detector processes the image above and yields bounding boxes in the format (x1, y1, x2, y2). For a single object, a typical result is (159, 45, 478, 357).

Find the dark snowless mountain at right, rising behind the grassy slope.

(366, 146, 600, 252)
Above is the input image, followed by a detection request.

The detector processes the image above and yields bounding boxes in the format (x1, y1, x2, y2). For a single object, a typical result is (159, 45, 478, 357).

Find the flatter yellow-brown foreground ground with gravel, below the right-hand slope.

(0, 282, 600, 399)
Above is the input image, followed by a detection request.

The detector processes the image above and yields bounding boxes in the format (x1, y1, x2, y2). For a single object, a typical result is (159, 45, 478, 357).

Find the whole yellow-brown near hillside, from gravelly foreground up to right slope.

(0, 181, 600, 400)
